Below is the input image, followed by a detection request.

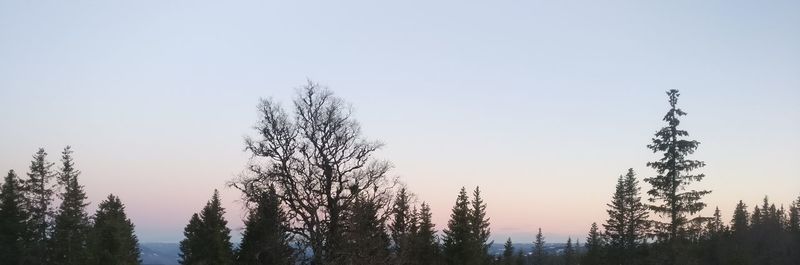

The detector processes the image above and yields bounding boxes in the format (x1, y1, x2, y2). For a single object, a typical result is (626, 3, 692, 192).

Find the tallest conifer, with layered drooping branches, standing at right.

(644, 89, 710, 248)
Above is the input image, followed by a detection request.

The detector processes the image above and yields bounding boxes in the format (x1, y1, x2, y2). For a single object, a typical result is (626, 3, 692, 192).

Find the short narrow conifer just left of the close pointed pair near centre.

(413, 202, 441, 265)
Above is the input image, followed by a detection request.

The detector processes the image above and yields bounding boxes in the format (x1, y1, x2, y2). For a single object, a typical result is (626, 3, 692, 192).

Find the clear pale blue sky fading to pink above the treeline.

(0, 1, 800, 242)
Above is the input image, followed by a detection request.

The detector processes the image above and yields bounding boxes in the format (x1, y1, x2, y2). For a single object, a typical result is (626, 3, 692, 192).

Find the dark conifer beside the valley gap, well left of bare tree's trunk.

(180, 190, 234, 265)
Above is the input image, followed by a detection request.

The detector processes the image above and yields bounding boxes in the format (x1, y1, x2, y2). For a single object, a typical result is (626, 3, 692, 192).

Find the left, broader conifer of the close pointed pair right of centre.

(442, 187, 477, 265)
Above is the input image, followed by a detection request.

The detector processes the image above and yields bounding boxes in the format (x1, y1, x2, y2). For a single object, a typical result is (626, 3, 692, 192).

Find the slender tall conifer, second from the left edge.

(24, 148, 55, 265)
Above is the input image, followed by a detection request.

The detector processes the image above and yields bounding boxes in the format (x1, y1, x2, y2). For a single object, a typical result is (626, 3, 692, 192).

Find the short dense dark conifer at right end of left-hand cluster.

(87, 194, 141, 265)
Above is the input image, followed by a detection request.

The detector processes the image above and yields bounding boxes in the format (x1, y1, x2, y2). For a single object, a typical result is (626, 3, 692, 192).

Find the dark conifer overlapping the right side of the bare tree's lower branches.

(343, 195, 390, 265)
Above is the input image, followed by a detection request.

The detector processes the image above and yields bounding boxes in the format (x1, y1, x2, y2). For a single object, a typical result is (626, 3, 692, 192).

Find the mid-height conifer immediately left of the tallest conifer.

(603, 168, 648, 264)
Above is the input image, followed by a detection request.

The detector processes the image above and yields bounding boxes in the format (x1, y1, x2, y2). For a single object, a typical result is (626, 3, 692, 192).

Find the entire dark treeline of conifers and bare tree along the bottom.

(0, 81, 800, 265)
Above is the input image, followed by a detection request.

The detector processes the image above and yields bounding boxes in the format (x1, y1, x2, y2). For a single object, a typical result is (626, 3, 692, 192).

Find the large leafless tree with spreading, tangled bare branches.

(232, 81, 393, 265)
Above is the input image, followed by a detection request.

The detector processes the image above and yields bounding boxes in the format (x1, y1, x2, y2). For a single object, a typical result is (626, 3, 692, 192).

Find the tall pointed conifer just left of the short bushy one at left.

(50, 146, 90, 265)
